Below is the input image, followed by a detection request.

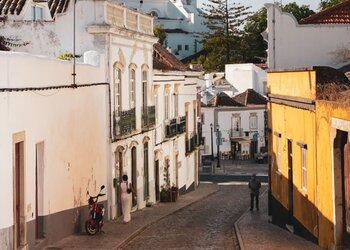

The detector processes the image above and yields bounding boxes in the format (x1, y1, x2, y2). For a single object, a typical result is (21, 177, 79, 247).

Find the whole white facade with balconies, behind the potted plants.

(153, 69, 201, 195)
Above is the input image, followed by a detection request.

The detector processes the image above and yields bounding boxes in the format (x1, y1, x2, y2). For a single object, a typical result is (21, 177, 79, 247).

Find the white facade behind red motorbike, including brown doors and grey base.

(0, 52, 109, 249)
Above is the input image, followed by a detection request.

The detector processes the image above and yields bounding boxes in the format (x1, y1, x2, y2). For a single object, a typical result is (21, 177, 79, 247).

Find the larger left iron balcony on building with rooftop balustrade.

(113, 109, 136, 139)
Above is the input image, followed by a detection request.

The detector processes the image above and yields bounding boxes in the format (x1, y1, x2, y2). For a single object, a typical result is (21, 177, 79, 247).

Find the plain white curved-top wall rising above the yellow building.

(265, 4, 350, 69)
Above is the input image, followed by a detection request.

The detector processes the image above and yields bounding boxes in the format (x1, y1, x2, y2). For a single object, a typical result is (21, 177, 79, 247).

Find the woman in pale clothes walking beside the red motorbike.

(119, 174, 136, 224)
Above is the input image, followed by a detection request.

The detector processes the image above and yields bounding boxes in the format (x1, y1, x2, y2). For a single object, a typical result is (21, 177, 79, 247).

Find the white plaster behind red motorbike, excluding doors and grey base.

(0, 52, 109, 229)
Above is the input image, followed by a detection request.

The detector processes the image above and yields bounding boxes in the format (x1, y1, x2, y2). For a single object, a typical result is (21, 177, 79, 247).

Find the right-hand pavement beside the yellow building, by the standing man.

(235, 192, 321, 250)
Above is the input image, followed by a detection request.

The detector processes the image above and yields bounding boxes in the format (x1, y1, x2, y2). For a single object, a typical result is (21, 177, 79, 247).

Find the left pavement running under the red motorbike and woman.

(46, 183, 219, 250)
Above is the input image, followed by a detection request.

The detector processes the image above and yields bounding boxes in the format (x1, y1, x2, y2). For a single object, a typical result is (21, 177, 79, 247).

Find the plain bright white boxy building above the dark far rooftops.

(225, 63, 266, 95)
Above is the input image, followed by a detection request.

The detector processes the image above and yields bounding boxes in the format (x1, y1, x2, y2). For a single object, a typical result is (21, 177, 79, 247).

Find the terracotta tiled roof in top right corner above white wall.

(299, 0, 350, 24)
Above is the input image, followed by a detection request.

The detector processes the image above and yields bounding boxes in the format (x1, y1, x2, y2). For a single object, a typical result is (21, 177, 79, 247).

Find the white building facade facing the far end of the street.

(201, 105, 266, 159)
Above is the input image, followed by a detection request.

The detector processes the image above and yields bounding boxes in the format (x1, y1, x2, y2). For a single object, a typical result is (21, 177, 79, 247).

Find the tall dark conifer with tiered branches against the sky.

(199, 0, 250, 71)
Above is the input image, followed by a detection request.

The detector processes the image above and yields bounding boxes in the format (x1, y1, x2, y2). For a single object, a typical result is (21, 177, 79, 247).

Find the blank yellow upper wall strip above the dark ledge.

(267, 71, 316, 100)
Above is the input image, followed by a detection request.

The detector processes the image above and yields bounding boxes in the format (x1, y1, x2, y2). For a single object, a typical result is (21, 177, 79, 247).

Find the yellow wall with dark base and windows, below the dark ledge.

(270, 103, 317, 237)
